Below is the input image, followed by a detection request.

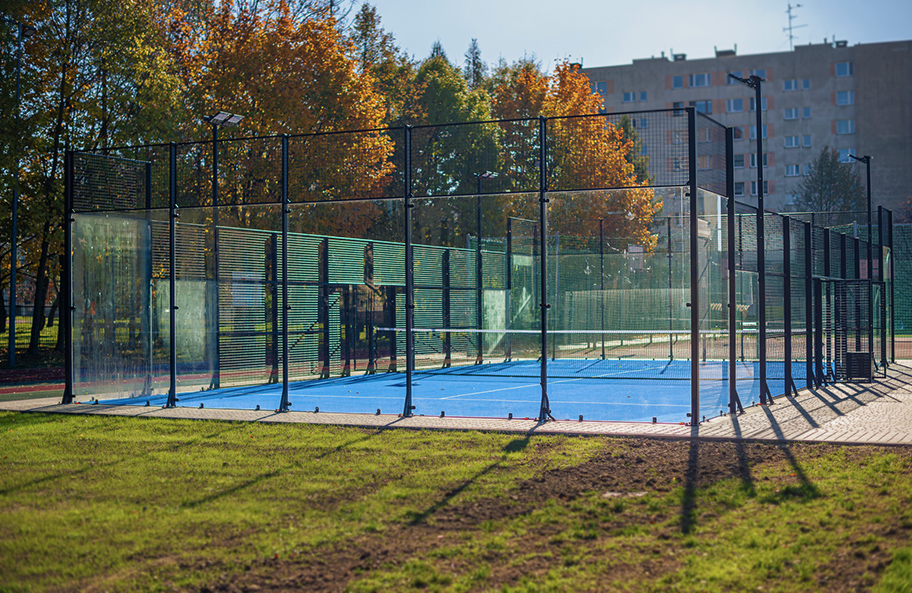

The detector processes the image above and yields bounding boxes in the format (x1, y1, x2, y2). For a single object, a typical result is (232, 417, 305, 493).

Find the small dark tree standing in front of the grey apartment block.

(795, 146, 866, 213)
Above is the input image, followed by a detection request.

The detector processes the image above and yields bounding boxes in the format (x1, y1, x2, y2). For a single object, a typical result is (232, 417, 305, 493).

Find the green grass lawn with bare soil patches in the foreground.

(0, 412, 912, 591)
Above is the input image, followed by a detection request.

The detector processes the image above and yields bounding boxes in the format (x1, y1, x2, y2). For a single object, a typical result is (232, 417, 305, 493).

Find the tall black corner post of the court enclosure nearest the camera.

(685, 107, 700, 424)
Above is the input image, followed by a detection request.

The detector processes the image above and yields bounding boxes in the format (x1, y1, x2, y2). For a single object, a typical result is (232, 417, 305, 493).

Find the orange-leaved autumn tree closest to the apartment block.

(493, 59, 662, 248)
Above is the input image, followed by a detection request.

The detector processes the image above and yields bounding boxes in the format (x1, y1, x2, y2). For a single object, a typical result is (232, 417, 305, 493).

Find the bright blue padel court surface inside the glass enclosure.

(87, 359, 806, 423)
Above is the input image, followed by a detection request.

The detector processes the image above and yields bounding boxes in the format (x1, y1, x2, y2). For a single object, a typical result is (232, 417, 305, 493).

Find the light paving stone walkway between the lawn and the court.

(0, 361, 912, 445)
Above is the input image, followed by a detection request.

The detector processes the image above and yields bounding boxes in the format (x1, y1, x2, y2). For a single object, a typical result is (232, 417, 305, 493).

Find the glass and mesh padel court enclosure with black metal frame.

(63, 107, 895, 423)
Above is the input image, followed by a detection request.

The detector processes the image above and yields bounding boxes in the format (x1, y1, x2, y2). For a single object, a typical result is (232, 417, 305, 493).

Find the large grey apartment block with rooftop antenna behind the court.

(582, 41, 912, 210)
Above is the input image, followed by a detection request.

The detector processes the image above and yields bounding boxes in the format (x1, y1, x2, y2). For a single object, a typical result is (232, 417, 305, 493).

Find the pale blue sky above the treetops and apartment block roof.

(370, 0, 912, 69)
